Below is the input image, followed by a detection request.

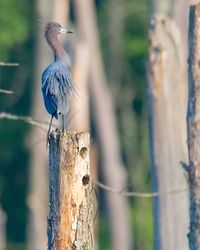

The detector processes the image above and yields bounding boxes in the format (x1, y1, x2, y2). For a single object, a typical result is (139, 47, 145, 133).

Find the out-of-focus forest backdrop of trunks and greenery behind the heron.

(0, 0, 189, 250)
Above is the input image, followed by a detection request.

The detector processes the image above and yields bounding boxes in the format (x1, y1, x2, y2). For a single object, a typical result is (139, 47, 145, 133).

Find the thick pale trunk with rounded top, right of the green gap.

(148, 15, 188, 250)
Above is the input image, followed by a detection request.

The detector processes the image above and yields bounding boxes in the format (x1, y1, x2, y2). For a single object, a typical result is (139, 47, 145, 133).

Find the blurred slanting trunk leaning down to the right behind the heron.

(74, 0, 131, 250)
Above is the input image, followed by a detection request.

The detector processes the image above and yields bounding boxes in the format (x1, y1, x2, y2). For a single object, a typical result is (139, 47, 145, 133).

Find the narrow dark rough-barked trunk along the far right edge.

(187, 4, 200, 250)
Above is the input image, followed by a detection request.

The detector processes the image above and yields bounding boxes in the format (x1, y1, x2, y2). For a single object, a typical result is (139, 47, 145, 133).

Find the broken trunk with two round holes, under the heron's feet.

(48, 130, 94, 250)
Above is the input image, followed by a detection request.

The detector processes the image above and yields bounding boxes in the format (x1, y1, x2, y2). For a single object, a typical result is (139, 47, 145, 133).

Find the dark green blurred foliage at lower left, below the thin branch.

(0, 121, 27, 241)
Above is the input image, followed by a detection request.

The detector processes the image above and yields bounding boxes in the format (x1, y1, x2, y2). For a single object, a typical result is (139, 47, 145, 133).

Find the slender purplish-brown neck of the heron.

(47, 34, 68, 61)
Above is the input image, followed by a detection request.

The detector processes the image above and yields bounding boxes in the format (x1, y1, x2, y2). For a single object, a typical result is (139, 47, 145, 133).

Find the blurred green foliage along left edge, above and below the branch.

(0, 0, 35, 247)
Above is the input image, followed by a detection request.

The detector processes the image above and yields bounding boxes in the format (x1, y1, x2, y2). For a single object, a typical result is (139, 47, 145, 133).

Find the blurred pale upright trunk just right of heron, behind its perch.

(69, 37, 101, 244)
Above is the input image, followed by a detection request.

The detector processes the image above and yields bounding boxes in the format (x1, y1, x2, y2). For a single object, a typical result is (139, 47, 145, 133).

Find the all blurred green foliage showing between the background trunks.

(0, 0, 153, 250)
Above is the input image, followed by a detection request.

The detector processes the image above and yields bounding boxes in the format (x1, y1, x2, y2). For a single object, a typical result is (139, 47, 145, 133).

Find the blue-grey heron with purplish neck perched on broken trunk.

(41, 22, 73, 145)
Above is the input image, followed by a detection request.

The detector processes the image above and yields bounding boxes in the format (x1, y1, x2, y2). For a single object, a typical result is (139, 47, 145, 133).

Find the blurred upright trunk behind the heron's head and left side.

(28, 0, 69, 250)
